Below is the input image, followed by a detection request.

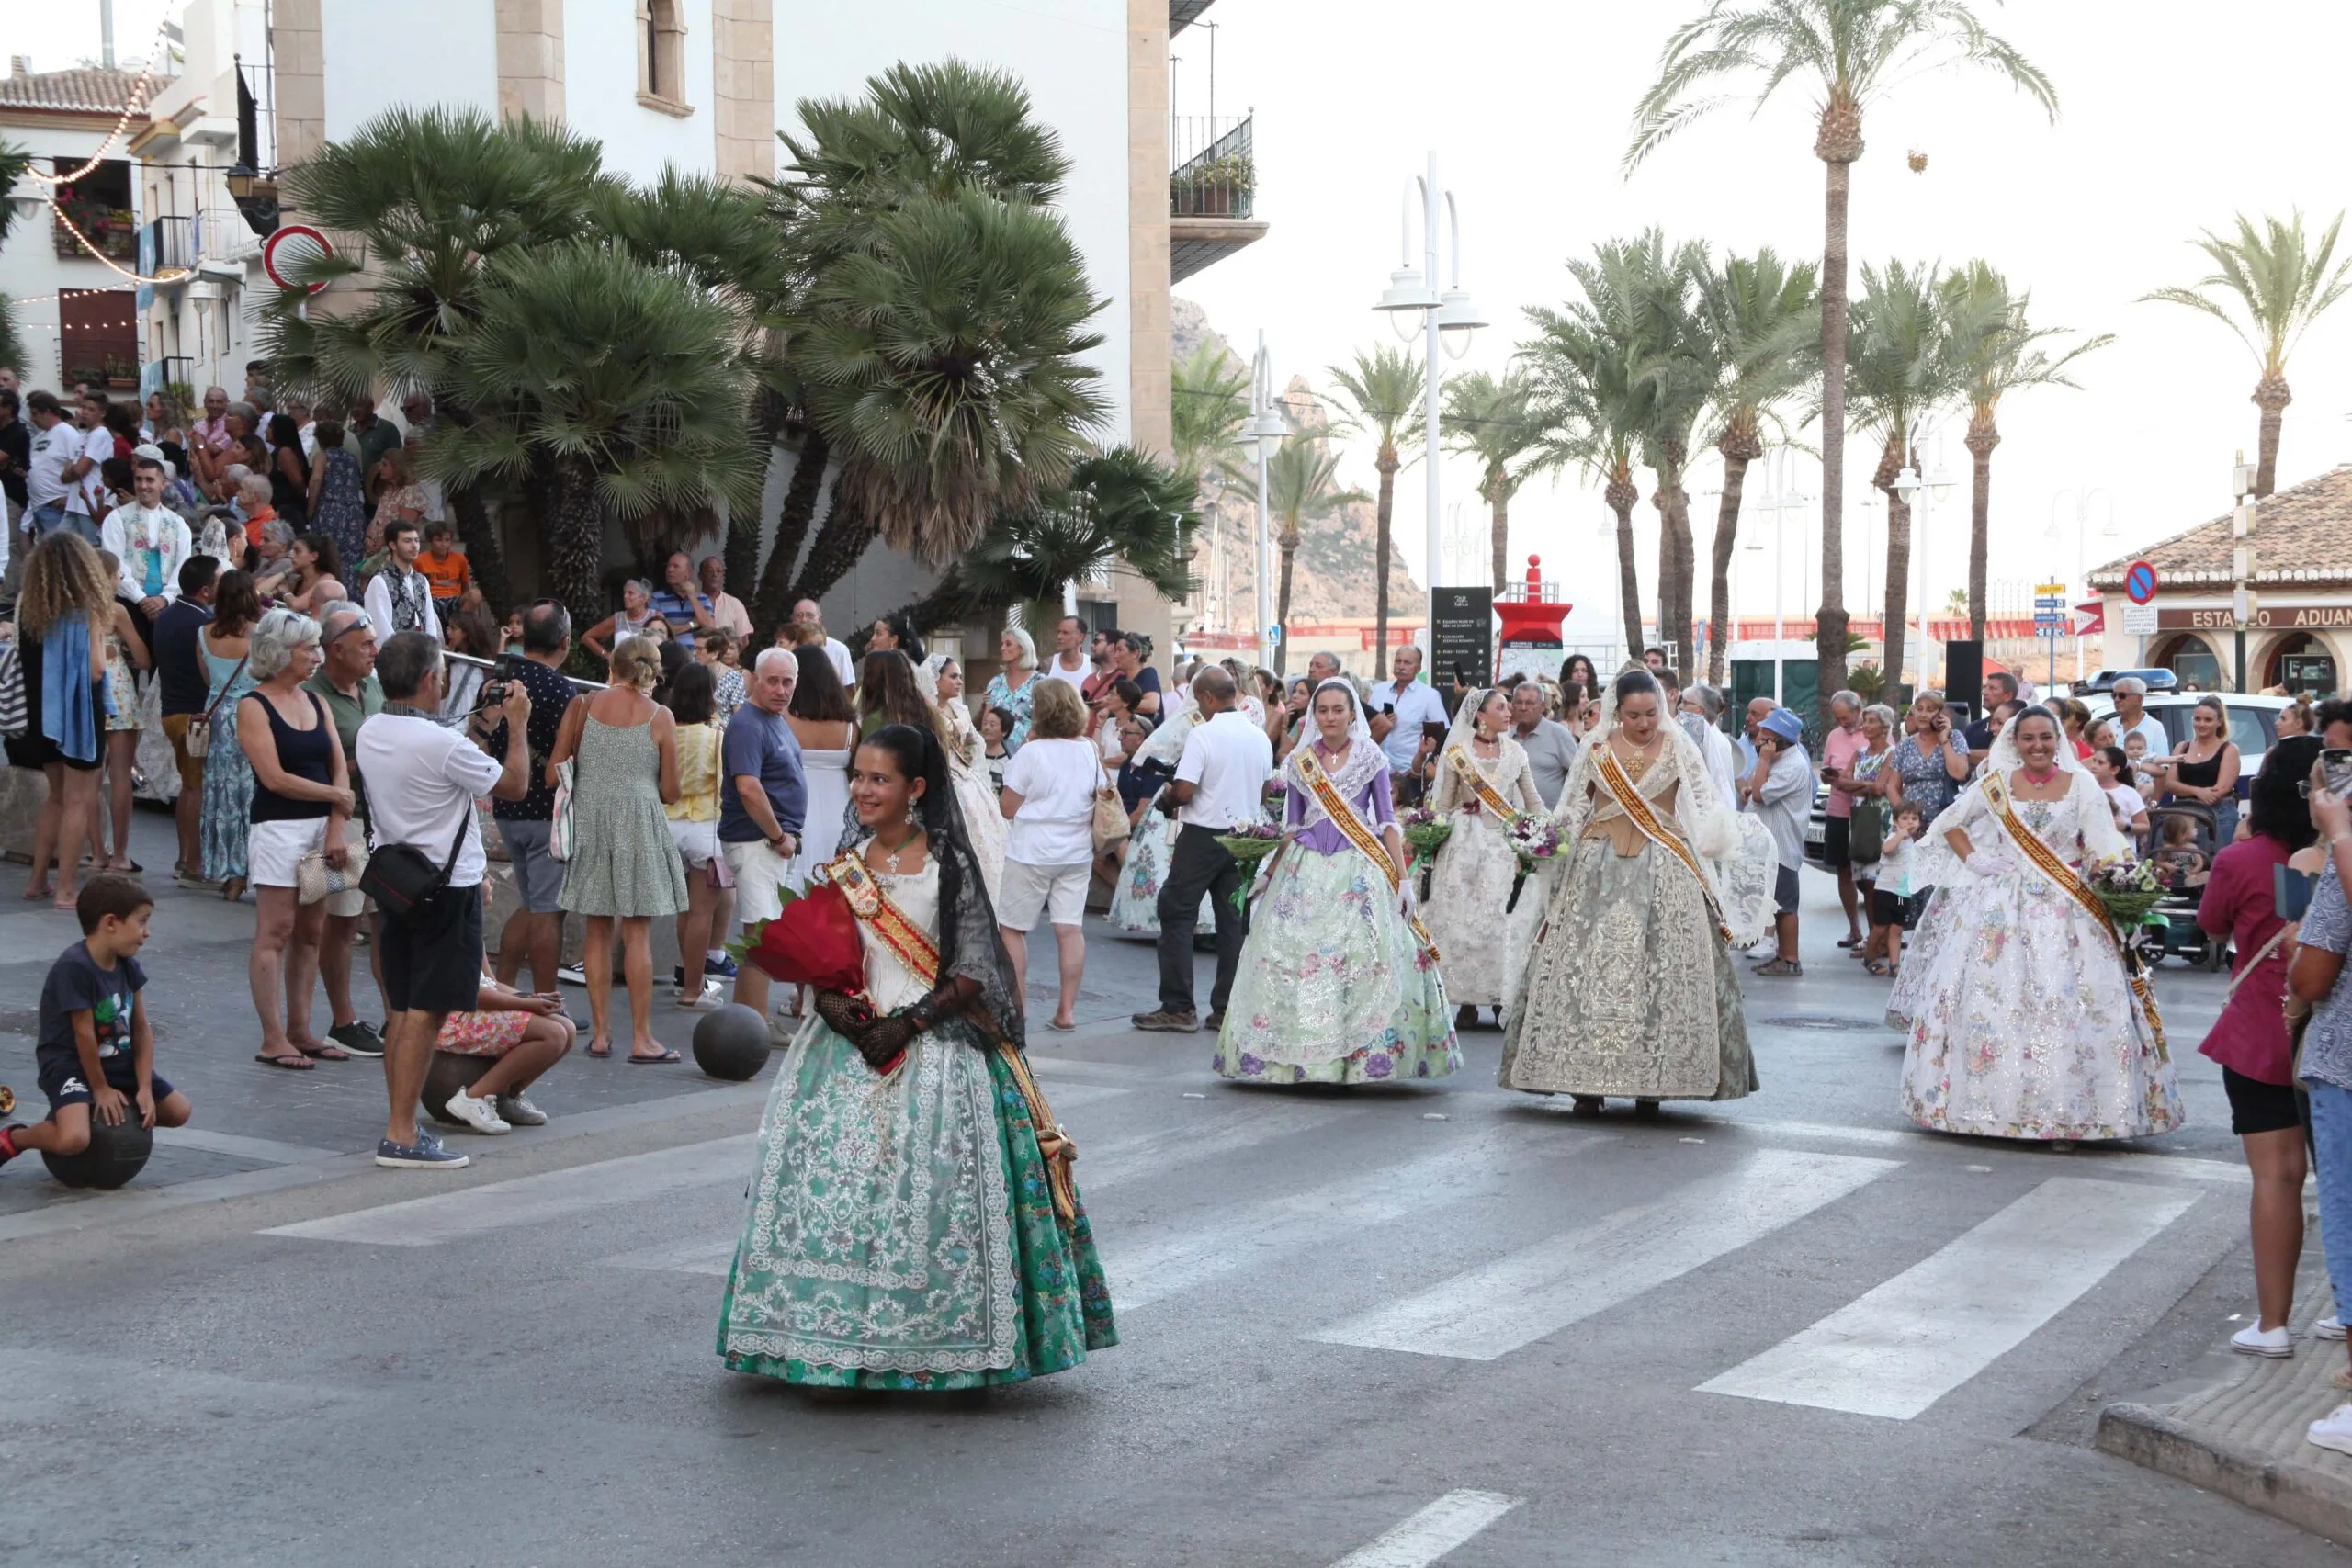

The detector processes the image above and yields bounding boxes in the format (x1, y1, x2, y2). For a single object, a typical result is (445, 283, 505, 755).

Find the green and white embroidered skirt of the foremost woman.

(718, 1018, 1120, 1389)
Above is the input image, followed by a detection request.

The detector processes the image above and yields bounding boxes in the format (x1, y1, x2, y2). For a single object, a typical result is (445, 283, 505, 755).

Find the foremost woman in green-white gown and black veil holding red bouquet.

(718, 724, 1117, 1389)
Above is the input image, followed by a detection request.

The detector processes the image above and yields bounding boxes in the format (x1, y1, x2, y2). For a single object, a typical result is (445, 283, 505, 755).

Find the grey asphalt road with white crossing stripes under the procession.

(0, 820, 2345, 1568)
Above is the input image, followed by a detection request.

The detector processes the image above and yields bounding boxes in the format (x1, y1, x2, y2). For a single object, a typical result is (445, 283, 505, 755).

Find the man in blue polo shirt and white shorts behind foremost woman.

(719, 649, 809, 1030)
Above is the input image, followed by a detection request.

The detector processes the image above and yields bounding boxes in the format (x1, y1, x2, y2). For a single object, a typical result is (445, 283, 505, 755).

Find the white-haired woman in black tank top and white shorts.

(235, 609, 356, 1072)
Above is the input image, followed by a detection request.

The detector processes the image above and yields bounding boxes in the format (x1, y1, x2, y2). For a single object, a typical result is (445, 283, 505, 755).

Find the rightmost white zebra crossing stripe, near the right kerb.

(1698, 1176, 2199, 1420)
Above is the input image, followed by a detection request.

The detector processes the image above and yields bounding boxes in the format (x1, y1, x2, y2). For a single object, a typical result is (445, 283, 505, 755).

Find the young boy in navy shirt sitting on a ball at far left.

(0, 874, 188, 1164)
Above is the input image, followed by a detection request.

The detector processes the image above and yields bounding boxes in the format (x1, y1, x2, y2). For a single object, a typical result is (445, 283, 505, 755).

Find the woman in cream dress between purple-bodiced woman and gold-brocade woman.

(1423, 686, 1543, 1030)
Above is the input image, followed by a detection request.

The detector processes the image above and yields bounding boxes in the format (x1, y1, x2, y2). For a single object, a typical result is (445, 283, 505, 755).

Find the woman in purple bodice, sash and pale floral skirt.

(1211, 680, 1463, 1084)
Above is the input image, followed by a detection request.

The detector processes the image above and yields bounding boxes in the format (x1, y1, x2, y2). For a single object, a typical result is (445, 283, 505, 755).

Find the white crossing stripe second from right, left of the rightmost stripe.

(1306, 1149, 1903, 1361)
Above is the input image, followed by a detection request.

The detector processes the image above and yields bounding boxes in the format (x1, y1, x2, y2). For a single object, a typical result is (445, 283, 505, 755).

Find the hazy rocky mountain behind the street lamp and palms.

(1171, 299, 1423, 627)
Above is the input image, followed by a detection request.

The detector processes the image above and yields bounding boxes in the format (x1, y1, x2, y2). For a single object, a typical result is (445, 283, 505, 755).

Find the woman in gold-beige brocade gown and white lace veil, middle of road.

(1496, 670, 1778, 1117)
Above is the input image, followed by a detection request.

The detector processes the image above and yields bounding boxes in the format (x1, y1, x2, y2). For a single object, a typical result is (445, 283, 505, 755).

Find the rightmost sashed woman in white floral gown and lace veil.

(1886, 707, 2183, 1147)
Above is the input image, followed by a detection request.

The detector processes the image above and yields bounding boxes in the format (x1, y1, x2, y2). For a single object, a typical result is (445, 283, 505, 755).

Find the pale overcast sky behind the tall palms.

(18, 0, 2352, 614)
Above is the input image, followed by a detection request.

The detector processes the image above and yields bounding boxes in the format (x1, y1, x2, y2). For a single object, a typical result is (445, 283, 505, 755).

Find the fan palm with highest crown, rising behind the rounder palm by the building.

(755, 59, 1070, 623)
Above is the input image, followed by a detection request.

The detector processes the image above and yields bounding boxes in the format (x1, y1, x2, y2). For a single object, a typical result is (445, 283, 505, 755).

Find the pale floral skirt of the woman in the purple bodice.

(1209, 844, 1463, 1084)
